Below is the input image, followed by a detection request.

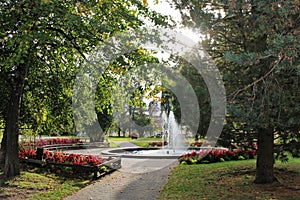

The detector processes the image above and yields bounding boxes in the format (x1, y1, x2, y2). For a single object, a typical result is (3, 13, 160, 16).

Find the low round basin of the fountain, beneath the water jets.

(101, 147, 226, 159)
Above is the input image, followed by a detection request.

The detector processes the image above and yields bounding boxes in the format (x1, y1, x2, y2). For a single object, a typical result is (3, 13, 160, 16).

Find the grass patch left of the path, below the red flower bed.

(0, 164, 92, 200)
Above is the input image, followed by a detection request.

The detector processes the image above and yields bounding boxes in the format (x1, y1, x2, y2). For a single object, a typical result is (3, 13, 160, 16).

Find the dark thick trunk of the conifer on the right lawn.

(254, 129, 277, 184)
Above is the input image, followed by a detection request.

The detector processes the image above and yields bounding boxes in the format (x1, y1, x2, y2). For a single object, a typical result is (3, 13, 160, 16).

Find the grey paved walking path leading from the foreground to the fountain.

(65, 144, 178, 200)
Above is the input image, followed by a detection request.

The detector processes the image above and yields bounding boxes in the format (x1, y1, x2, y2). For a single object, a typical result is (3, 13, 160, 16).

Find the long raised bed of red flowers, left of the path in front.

(19, 149, 121, 179)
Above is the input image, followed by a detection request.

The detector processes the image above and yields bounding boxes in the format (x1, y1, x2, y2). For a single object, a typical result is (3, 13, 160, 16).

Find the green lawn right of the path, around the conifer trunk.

(158, 159, 300, 200)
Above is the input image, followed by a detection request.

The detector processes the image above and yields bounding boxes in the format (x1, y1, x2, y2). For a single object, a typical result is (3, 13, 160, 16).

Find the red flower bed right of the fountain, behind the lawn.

(179, 149, 256, 164)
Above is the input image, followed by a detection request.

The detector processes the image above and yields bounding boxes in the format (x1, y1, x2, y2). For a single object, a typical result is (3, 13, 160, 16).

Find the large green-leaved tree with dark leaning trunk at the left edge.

(0, 0, 165, 178)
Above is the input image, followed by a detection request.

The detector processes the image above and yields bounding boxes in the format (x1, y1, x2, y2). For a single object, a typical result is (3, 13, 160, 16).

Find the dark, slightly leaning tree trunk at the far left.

(4, 62, 30, 179)
